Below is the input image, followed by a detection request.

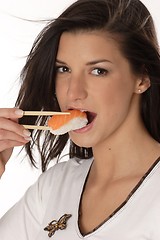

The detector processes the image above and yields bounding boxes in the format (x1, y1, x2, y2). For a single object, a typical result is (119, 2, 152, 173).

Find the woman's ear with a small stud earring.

(135, 74, 151, 94)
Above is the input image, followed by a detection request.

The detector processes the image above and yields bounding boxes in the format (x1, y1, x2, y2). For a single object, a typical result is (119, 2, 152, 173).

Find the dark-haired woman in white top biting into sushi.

(0, 0, 160, 240)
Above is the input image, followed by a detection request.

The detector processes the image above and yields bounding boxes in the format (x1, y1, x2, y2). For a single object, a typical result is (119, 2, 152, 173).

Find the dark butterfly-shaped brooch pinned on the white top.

(44, 214, 72, 237)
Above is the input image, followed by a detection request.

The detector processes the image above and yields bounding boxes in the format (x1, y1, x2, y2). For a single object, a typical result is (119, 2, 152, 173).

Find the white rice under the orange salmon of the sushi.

(50, 117, 88, 135)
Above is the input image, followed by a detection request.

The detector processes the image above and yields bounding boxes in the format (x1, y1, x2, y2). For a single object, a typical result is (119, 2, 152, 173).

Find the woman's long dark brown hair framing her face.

(16, 0, 160, 171)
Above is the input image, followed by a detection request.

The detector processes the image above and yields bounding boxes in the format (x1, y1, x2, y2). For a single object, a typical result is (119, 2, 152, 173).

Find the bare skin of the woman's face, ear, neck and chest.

(56, 31, 160, 234)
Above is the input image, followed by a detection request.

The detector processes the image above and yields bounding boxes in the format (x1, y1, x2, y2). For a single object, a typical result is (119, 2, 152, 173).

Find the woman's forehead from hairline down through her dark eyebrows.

(57, 30, 129, 68)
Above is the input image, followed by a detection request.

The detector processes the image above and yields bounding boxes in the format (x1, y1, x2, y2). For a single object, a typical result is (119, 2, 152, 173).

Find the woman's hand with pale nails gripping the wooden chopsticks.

(0, 108, 30, 176)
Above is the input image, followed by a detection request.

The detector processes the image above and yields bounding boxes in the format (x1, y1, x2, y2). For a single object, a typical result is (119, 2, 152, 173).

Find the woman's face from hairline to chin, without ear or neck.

(56, 31, 139, 147)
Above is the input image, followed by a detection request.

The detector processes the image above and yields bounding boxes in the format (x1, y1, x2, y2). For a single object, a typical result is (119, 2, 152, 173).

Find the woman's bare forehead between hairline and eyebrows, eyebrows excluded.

(58, 30, 123, 61)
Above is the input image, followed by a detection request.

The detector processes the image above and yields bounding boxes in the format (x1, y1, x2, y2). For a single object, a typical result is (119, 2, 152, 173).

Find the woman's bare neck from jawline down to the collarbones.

(92, 118, 160, 182)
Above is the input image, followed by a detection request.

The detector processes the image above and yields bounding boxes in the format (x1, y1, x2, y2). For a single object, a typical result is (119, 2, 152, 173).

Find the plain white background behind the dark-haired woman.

(0, 0, 160, 217)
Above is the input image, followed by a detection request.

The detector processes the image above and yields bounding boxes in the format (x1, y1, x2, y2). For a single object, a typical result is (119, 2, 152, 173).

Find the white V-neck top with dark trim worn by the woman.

(0, 159, 160, 240)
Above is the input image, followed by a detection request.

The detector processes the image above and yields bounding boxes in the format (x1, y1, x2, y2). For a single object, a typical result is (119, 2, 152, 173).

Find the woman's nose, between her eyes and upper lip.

(67, 74, 88, 102)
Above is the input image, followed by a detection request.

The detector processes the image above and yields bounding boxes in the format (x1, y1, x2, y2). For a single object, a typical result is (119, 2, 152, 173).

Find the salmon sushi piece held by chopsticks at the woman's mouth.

(48, 109, 88, 135)
